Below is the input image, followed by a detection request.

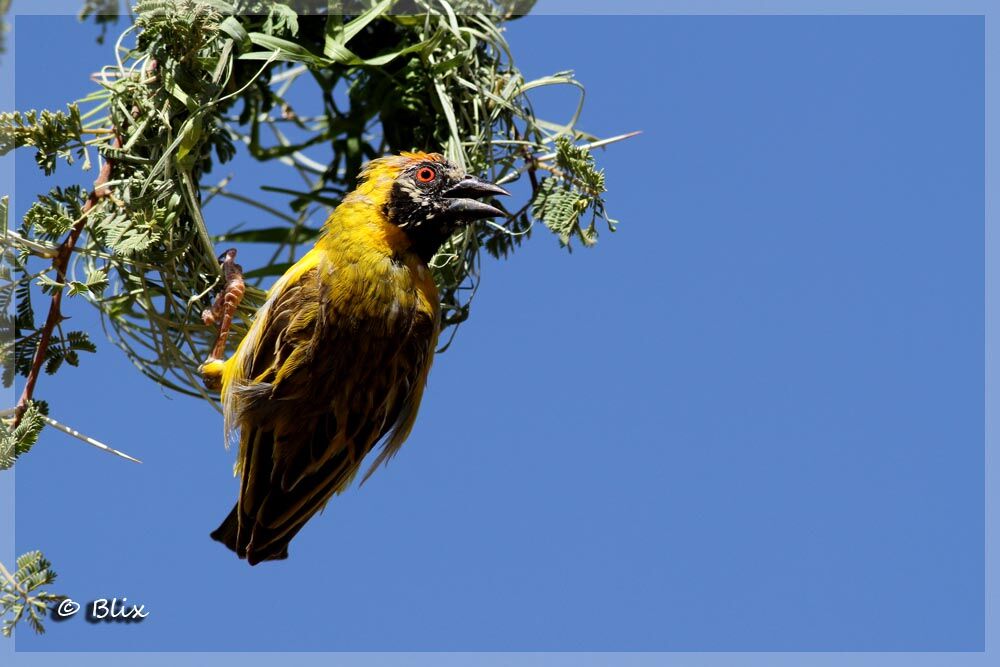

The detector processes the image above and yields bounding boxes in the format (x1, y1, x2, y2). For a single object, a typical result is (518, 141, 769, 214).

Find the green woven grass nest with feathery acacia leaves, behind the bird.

(0, 0, 614, 396)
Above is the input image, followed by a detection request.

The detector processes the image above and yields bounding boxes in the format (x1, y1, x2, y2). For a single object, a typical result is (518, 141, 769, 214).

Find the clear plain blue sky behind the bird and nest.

(0, 10, 984, 651)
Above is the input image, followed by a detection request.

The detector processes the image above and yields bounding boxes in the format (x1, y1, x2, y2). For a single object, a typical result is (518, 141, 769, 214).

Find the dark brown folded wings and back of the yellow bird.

(223, 258, 437, 564)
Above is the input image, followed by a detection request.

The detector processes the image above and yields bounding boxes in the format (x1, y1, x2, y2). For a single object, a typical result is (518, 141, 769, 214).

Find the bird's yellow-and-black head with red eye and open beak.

(355, 153, 510, 261)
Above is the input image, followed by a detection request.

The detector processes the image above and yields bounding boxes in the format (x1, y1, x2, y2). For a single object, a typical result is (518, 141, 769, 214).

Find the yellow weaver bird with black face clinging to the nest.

(202, 153, 508, 565)
